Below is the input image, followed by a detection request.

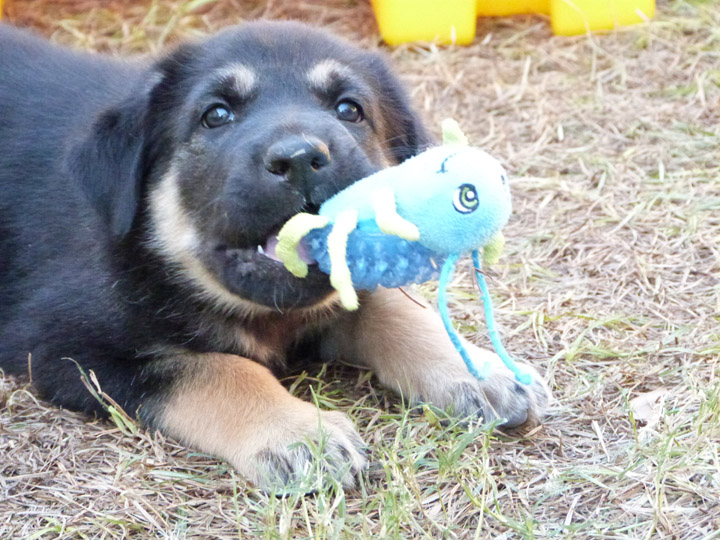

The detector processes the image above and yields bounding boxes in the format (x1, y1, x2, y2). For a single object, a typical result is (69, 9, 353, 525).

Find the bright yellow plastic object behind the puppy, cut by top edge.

(372, 0, 655, 45)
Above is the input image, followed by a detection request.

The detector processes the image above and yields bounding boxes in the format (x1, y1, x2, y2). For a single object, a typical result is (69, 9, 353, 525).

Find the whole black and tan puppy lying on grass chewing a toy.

(0, 22, 547, 486)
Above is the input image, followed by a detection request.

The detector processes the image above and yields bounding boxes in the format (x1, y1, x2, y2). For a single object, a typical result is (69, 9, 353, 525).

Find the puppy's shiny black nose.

(264, 135, 330, 185)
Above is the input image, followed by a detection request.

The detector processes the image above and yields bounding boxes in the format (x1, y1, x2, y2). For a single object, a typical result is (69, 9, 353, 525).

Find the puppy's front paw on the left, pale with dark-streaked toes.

(240, 402, 366, 493)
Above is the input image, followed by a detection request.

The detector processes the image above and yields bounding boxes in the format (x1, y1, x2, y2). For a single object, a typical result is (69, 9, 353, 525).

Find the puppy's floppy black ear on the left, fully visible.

(66, 88, 148, 237)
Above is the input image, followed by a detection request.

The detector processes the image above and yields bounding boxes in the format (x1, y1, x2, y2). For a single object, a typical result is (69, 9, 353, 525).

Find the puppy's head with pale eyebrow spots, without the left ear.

(79, 22, 427, 309)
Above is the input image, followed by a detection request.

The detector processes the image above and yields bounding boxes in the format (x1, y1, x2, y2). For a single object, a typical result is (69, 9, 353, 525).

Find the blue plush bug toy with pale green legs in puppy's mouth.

(275, 120, 531, 384)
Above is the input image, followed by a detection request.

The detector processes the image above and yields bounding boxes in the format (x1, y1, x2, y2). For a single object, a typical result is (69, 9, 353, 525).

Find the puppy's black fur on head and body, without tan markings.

(0, 23, 428, 423)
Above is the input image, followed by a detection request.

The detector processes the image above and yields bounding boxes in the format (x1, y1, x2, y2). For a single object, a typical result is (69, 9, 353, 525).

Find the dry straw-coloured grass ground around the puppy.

(0, 0, 720, 540)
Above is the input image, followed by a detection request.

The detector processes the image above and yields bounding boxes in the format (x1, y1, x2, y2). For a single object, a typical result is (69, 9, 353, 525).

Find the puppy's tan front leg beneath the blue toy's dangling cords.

(323, 289, 550, 426)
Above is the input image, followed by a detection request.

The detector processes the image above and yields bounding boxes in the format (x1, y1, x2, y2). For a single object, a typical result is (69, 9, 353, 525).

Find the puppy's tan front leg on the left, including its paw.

(151, 354, 365, 489)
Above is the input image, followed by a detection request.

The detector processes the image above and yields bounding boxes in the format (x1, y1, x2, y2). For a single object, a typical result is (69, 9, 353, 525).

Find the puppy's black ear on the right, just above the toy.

(369, 54, 435, 164)
